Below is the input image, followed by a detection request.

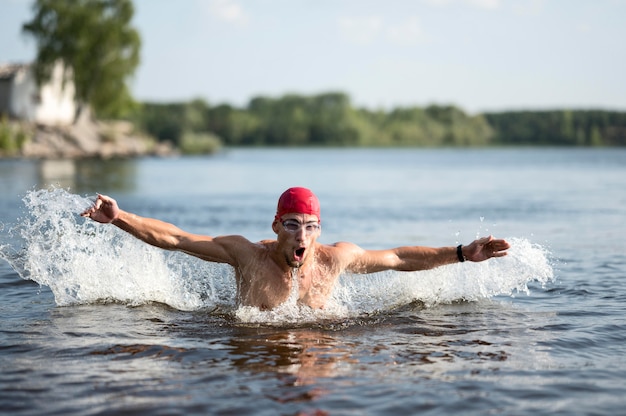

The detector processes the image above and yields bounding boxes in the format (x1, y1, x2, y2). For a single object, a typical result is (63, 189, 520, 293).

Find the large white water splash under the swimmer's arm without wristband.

(0, 189, 235, 310)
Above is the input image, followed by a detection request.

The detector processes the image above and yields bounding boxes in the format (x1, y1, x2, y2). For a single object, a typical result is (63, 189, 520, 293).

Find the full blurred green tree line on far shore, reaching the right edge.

(125, 92, 626, 151)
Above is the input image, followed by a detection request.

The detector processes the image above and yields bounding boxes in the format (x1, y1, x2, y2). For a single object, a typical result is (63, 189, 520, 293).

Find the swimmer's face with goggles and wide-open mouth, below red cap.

(275, 214, 321, 267)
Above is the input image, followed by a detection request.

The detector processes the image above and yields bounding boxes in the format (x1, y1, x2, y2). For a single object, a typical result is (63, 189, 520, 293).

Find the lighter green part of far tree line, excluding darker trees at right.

(130, 92, 493, 150)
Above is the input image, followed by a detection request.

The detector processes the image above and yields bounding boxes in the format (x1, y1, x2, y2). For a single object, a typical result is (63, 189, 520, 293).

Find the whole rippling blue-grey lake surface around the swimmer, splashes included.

(0, 149, 626, 415)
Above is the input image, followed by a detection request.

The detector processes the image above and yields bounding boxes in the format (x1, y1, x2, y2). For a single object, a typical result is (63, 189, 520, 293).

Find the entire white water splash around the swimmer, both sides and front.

(0, 189, 553, 324)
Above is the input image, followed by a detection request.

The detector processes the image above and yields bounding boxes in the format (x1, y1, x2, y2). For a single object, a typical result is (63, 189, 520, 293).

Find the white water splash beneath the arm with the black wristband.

(334, 238, 554, 310)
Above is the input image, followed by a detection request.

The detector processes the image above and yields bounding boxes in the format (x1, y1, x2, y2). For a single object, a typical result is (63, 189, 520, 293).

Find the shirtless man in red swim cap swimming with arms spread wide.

(81, 187, 510, 309)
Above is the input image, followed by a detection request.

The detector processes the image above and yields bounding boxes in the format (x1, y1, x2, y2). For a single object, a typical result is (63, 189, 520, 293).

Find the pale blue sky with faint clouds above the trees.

(0, 0, 626, 113)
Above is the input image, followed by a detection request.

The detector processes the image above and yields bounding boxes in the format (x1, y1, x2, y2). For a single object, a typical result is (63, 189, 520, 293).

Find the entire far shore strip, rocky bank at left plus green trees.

(0, 92, 626, 159)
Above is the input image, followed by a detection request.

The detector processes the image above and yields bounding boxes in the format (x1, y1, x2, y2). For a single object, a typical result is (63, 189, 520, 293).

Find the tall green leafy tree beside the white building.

(22, 0, 141, 119)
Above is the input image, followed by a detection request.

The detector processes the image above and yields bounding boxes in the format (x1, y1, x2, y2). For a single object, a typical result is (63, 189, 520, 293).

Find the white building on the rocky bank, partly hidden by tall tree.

(0, 63, 76, 126)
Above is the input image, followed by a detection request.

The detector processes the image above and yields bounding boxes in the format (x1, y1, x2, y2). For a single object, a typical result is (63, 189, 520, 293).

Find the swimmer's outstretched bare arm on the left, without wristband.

(81, 195, 239, 264)
